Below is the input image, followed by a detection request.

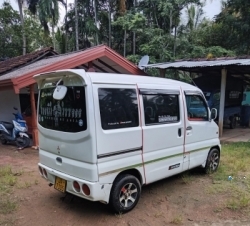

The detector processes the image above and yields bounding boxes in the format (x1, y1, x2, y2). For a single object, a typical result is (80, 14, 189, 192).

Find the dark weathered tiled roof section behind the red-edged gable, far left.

(0, 47, 58, 76)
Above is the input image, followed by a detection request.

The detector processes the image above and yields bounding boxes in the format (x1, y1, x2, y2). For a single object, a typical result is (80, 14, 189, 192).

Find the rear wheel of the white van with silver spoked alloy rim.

(109, 174, 141, 213)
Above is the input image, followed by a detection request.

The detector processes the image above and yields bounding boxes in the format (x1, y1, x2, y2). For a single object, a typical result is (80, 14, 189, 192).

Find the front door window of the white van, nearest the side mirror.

(186, 95, 208, 121)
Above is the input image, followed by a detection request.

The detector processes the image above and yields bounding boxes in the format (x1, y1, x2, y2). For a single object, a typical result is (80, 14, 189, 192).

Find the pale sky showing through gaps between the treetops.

(0, 0, 221, 24)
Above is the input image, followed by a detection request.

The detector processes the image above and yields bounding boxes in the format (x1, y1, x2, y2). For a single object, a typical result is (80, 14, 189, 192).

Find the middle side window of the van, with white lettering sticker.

(142, 94, 180, 125)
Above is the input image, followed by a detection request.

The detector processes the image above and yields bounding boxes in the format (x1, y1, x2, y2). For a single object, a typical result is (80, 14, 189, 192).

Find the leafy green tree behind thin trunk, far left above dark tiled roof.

(0, 3, 52, 58)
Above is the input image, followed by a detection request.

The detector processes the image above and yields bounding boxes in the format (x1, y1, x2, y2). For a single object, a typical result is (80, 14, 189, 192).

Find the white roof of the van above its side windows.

(87, 70, 199, 90)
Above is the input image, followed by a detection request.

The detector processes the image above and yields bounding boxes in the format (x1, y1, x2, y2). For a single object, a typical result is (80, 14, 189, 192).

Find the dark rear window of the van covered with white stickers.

(38, 86, 87, 133)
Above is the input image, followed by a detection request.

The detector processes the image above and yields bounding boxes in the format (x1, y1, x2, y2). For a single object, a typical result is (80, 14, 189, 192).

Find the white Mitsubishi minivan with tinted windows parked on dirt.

(34, 69, 221, 212)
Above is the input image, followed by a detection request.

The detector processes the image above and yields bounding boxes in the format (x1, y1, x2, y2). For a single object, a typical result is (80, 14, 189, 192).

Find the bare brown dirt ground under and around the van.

(0, 145, 250, 226)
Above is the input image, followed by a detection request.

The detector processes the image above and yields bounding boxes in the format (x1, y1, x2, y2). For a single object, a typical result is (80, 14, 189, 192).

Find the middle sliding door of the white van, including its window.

(138, 84, 184, 184)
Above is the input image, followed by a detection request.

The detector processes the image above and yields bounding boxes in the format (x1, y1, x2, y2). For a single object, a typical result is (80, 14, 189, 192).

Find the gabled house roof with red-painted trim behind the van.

(0, 45, 146, 93)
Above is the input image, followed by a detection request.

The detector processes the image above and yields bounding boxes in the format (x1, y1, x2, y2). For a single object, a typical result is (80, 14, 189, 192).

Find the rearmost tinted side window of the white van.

(98, 88, 139, 130)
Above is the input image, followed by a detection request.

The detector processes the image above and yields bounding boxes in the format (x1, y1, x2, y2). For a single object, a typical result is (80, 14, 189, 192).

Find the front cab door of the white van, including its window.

(183, 90, 218, 169)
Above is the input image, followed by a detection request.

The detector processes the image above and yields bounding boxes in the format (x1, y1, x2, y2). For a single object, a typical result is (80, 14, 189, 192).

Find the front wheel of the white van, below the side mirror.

(205, 148, 220, 174)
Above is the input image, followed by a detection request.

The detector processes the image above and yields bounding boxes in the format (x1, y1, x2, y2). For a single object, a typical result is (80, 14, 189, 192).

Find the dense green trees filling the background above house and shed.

(0, 0, 250, 63)
